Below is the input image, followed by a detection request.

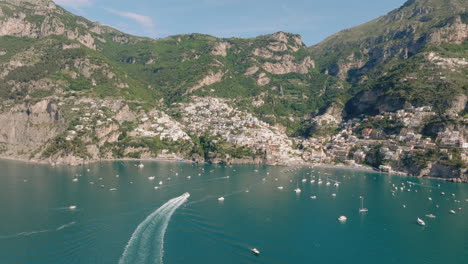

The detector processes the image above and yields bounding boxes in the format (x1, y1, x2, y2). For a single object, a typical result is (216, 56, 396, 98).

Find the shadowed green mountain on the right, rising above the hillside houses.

(309, 0, 468, 116)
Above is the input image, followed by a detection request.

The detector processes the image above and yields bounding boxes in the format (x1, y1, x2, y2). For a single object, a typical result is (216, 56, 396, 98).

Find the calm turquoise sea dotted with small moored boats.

(0, 161, 468, 264)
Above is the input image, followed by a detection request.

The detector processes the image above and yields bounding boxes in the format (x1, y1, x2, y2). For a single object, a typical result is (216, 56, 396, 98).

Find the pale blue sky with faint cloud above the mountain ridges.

(54, 0, 405, 45)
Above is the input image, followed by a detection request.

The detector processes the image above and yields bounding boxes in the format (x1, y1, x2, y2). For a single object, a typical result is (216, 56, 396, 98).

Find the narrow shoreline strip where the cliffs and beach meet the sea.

(0, 156, 468, 183)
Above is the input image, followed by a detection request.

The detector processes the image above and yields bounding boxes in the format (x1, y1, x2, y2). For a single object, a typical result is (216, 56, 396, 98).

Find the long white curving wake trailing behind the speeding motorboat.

(119, 193, 190, 264)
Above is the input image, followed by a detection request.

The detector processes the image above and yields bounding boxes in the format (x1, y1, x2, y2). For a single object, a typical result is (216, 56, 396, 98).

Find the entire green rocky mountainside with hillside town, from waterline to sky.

(0, 0, 468, 182)
